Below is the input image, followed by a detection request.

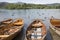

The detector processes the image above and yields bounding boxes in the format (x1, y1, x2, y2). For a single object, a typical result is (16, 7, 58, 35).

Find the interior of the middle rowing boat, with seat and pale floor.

(27, 20, 46, 40)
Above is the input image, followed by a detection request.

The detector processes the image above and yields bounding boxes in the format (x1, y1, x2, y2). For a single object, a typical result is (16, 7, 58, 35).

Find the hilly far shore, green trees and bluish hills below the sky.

(0, 2, 60, 9)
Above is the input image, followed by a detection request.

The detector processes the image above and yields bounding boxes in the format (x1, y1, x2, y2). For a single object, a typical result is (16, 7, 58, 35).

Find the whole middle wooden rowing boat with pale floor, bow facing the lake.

(26, 19, 47, 40)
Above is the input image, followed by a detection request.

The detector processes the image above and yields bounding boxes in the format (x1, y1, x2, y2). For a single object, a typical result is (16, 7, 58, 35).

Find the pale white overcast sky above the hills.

(0, 0, 60, 4)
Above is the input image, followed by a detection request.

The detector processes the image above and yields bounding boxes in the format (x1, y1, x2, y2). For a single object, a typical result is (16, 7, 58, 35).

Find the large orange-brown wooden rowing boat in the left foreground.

(0, 19, 24, 40)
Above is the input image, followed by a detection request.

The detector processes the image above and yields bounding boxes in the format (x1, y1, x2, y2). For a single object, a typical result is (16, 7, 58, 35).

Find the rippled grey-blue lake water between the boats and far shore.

(0, 9, 60, 40)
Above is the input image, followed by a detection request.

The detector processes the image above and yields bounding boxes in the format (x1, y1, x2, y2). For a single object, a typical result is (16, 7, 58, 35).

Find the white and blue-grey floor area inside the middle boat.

(31, 28, 42, 40)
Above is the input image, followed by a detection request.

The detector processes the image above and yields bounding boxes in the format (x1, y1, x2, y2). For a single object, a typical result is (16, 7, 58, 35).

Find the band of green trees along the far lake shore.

(0, 3, 60, 9)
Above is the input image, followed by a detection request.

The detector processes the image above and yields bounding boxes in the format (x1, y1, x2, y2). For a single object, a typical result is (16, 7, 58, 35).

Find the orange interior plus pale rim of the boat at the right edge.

(50, 19, 60, 35)
